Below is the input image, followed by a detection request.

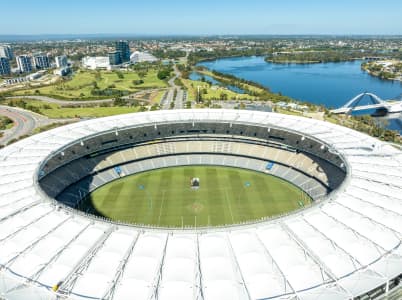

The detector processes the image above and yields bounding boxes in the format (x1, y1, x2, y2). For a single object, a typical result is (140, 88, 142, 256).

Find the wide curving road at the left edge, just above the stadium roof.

(0, 105, 76, 145)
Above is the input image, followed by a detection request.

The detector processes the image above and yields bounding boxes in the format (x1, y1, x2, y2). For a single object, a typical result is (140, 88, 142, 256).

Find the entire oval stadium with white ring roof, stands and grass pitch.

(0, 109, 402, 300)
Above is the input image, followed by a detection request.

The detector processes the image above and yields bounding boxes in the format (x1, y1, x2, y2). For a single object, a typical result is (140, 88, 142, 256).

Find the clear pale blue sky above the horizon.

(0, 0, 402, 35)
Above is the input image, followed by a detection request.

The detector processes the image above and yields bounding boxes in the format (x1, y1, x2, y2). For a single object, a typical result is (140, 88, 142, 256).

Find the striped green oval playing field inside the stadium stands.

(86, 166, 311, 227)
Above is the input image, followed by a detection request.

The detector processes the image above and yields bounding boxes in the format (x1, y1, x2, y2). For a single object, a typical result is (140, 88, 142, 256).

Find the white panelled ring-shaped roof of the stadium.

(0, 110, 402, 300)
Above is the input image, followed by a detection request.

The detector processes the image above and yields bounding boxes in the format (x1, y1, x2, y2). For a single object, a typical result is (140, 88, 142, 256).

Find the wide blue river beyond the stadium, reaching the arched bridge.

(199, 56, 402, 108)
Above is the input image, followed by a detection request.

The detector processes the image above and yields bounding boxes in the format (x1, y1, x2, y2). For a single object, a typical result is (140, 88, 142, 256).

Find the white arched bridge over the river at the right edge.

(331, 92, 402, 114)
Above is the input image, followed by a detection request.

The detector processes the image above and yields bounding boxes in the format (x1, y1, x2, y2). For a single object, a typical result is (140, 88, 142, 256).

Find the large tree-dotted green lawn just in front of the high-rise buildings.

(14, 69, 167, 99)
